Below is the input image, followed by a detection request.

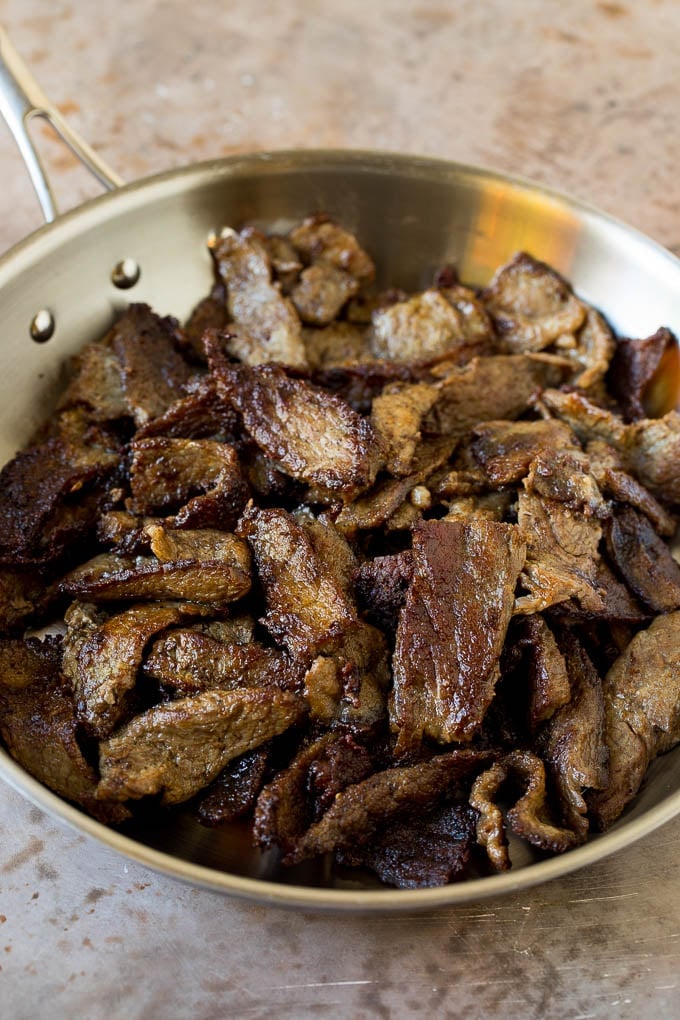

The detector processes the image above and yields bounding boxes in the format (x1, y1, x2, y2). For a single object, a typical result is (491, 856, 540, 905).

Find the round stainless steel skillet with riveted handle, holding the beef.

(0, 32, 680, 911)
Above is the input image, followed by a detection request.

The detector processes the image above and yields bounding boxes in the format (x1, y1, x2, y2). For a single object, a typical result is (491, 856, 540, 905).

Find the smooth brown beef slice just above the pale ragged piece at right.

(471, 418, 580, 488)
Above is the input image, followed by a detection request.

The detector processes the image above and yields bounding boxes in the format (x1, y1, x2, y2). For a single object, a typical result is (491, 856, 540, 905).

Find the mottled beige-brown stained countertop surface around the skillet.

(0, 0, 680, 1020)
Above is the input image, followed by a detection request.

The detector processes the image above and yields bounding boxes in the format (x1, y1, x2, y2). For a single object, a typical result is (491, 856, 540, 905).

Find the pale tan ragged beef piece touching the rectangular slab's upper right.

(515, 492, 606, 615)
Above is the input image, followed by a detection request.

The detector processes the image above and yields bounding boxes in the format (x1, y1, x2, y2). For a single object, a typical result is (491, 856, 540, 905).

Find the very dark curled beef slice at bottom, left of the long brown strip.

(253, 732, 374, 853)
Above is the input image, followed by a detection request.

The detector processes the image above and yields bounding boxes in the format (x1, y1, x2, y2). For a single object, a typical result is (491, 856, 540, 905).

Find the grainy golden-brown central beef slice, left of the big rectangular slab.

(239, 507, 357, 661)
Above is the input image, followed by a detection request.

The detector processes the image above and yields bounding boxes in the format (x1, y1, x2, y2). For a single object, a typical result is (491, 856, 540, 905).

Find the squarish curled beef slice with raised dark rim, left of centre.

(128, 437, 248, 530)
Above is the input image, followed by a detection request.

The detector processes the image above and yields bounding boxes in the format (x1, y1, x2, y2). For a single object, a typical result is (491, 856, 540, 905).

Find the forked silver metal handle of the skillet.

(0, 26, 124, 223)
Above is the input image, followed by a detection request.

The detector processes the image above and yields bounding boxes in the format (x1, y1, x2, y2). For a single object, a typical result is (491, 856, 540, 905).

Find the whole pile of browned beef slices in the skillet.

(0, 216, 680, 887)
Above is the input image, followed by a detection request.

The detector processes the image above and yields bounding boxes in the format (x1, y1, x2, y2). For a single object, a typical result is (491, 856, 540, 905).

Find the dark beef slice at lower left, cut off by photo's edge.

(0, 639, 127, 824)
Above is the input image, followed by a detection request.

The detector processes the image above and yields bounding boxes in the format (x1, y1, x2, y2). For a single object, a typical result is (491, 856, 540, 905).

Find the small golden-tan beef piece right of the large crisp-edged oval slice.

(371, 383, 438, 477)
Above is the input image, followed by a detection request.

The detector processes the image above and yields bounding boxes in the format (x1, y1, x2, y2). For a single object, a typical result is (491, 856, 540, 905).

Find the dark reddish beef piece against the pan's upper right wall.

(608, 327, 678, 421)
